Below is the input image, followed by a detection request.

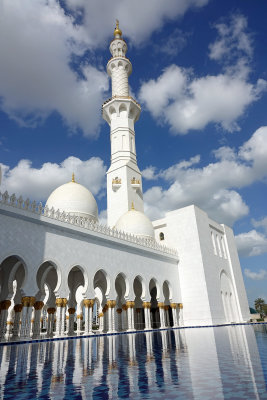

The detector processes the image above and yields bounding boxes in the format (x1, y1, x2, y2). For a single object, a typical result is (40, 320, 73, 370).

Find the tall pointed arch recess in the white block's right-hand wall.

(220, 270, 239, 322)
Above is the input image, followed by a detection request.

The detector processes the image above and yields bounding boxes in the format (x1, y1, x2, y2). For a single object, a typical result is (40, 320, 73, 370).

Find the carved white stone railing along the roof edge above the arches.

(0, 191, 180, 256)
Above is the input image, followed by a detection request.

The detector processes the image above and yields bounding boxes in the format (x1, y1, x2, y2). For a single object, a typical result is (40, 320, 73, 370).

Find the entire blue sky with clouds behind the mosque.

(0, 0, 267, 305)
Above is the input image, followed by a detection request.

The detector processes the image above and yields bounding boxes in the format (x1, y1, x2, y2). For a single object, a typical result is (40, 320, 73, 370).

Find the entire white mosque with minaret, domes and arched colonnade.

(0, 23, 250, 341)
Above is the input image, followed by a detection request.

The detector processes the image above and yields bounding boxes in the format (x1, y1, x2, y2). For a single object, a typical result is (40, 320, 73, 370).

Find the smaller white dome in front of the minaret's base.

(115, 209, 154, 239)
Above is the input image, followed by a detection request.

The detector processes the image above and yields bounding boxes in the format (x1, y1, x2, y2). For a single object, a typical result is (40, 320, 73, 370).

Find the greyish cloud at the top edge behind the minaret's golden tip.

(66, 0, 209, 46)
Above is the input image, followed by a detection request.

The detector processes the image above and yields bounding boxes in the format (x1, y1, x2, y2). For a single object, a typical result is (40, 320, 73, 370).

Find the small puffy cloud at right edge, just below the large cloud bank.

(235, 229, 267, 257)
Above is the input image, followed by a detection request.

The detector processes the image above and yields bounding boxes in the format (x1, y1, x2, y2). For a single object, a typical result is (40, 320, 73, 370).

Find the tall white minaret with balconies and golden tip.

(102, 21, 144, 227)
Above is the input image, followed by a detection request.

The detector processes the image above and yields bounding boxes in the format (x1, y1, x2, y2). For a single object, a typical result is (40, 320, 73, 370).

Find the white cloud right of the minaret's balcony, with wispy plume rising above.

(139, 15, 267, 134)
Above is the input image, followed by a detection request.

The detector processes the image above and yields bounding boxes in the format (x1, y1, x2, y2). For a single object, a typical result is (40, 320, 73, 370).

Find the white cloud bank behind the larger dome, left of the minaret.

(1, 157, 106, 202)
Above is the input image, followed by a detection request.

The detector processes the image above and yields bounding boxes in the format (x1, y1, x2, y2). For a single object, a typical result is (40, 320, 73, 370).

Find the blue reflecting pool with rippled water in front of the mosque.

(0, 325, 267, 400)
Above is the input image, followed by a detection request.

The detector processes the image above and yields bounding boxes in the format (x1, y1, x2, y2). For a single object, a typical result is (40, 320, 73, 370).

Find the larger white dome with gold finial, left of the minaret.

(46, 182, 98, 221)
